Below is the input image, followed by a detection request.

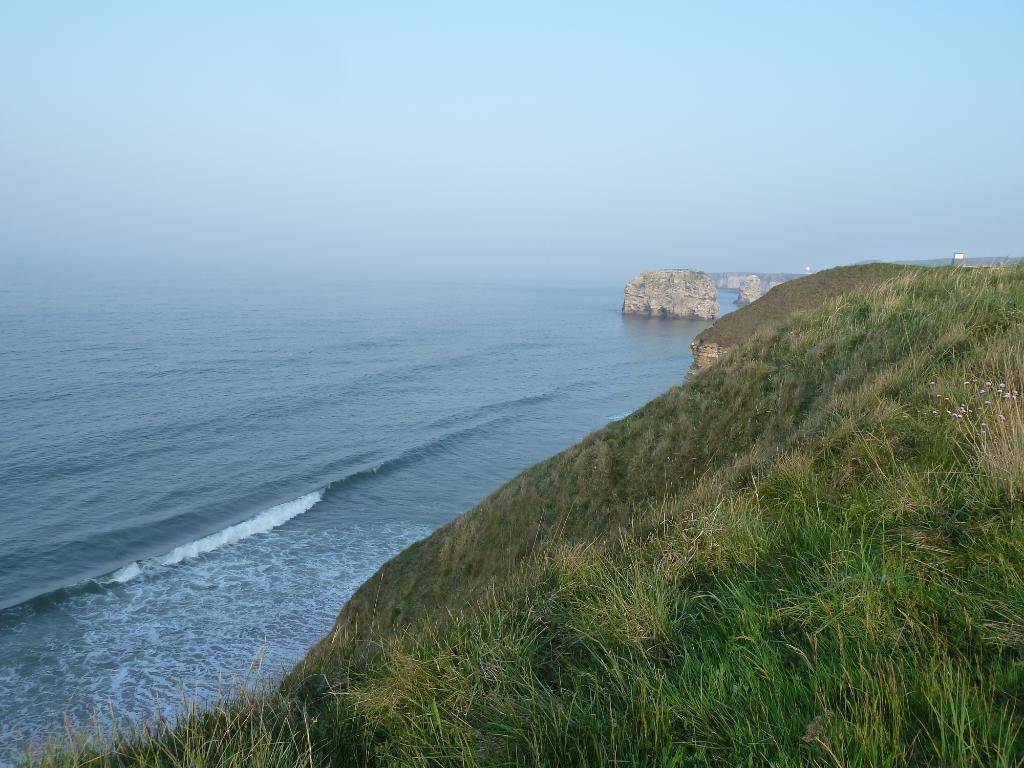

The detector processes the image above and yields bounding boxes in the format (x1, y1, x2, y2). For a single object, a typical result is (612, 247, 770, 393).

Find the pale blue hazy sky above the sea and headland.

(0, 0, 1024, 278)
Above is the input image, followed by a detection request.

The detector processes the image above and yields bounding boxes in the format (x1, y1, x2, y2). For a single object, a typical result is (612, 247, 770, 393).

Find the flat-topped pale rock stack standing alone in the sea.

(623, 269, 721, 319)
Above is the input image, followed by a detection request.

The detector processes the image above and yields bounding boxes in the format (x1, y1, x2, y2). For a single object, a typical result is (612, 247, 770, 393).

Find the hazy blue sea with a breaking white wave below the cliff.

(0, 280, 731, 762)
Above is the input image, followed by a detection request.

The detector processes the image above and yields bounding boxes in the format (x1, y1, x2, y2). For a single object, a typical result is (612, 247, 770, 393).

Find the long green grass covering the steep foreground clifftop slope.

(32, 269, 1024, 768)
